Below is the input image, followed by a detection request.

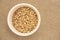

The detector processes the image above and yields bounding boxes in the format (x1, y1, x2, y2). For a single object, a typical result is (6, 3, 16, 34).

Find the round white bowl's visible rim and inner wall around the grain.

(7, 3, 41, 36)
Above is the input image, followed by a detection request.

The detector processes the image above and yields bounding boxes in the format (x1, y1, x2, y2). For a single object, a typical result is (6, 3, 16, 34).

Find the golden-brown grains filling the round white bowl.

(12, 7, 38, 33)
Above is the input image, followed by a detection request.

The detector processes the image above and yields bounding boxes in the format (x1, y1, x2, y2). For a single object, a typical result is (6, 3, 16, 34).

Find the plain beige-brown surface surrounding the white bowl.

(0, 0, 60, 40)
